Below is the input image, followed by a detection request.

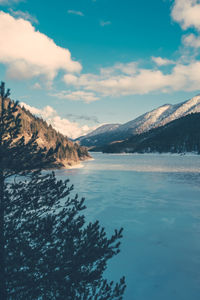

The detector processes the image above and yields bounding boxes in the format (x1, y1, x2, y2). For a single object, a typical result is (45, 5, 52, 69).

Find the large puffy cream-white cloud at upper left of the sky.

(0, 12, 82, 81)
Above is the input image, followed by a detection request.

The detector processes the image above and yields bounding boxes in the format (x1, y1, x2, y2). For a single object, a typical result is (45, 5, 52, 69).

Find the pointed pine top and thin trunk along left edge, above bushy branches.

(0, 82, 54, 300)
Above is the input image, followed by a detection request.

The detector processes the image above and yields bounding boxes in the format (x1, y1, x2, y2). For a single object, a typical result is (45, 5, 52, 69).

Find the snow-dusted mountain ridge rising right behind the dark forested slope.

(79, 95, 200, 146)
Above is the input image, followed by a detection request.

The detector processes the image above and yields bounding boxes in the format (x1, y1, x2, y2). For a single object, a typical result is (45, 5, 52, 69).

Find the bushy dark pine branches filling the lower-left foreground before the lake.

(6, 172, 125, 300)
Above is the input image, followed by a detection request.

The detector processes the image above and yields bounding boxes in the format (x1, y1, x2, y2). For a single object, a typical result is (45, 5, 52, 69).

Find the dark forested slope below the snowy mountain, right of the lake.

(97, 113, 200, 154)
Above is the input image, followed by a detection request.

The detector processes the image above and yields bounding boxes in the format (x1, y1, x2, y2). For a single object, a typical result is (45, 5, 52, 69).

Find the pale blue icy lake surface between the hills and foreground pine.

(57, 153, 200, 300)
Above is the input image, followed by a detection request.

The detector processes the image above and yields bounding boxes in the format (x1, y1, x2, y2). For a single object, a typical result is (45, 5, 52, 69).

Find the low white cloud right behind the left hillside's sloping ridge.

(20, 102, 99, 139)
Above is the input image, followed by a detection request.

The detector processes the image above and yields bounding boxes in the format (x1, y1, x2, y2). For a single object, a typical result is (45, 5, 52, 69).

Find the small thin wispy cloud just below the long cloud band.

(50, 91, 99, 103)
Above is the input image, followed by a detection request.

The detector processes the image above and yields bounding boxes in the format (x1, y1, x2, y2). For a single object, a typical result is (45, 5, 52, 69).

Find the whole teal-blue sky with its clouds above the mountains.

(0, 0, 200, 138)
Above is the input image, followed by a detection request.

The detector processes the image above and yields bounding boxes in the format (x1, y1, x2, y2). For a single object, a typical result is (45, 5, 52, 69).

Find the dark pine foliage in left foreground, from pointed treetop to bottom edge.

(0, 83, 125, 300)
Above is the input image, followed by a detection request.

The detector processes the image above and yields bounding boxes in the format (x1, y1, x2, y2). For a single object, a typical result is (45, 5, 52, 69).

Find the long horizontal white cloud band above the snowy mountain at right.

(62, 60, 200, 97)
